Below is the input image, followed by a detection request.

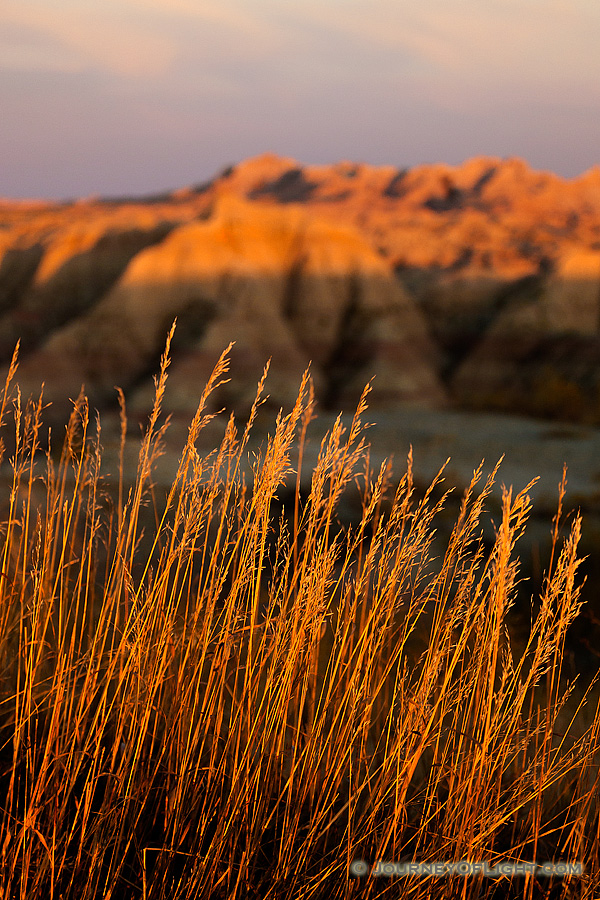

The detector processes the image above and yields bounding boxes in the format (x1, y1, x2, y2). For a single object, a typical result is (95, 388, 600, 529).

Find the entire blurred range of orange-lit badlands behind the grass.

(0, 155, 600, 432)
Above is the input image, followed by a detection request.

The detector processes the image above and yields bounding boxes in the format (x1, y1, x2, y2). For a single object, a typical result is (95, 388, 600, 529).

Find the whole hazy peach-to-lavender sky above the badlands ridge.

(0, 0, 600, 199)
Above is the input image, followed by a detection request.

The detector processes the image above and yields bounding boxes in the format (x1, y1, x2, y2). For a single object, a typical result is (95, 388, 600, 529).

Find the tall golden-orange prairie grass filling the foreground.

(0, 330, 600, 900)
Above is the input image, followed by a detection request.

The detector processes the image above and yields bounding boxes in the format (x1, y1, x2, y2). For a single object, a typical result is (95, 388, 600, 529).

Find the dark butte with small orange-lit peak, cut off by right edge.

(452, 248, 600, 424)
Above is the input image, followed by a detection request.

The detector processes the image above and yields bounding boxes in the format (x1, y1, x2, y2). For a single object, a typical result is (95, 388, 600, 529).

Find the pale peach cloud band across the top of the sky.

(5, 0, 600, 96)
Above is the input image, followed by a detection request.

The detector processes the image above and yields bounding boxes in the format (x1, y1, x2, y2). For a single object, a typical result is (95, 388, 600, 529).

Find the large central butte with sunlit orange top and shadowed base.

(5, 196, 444, 432)
